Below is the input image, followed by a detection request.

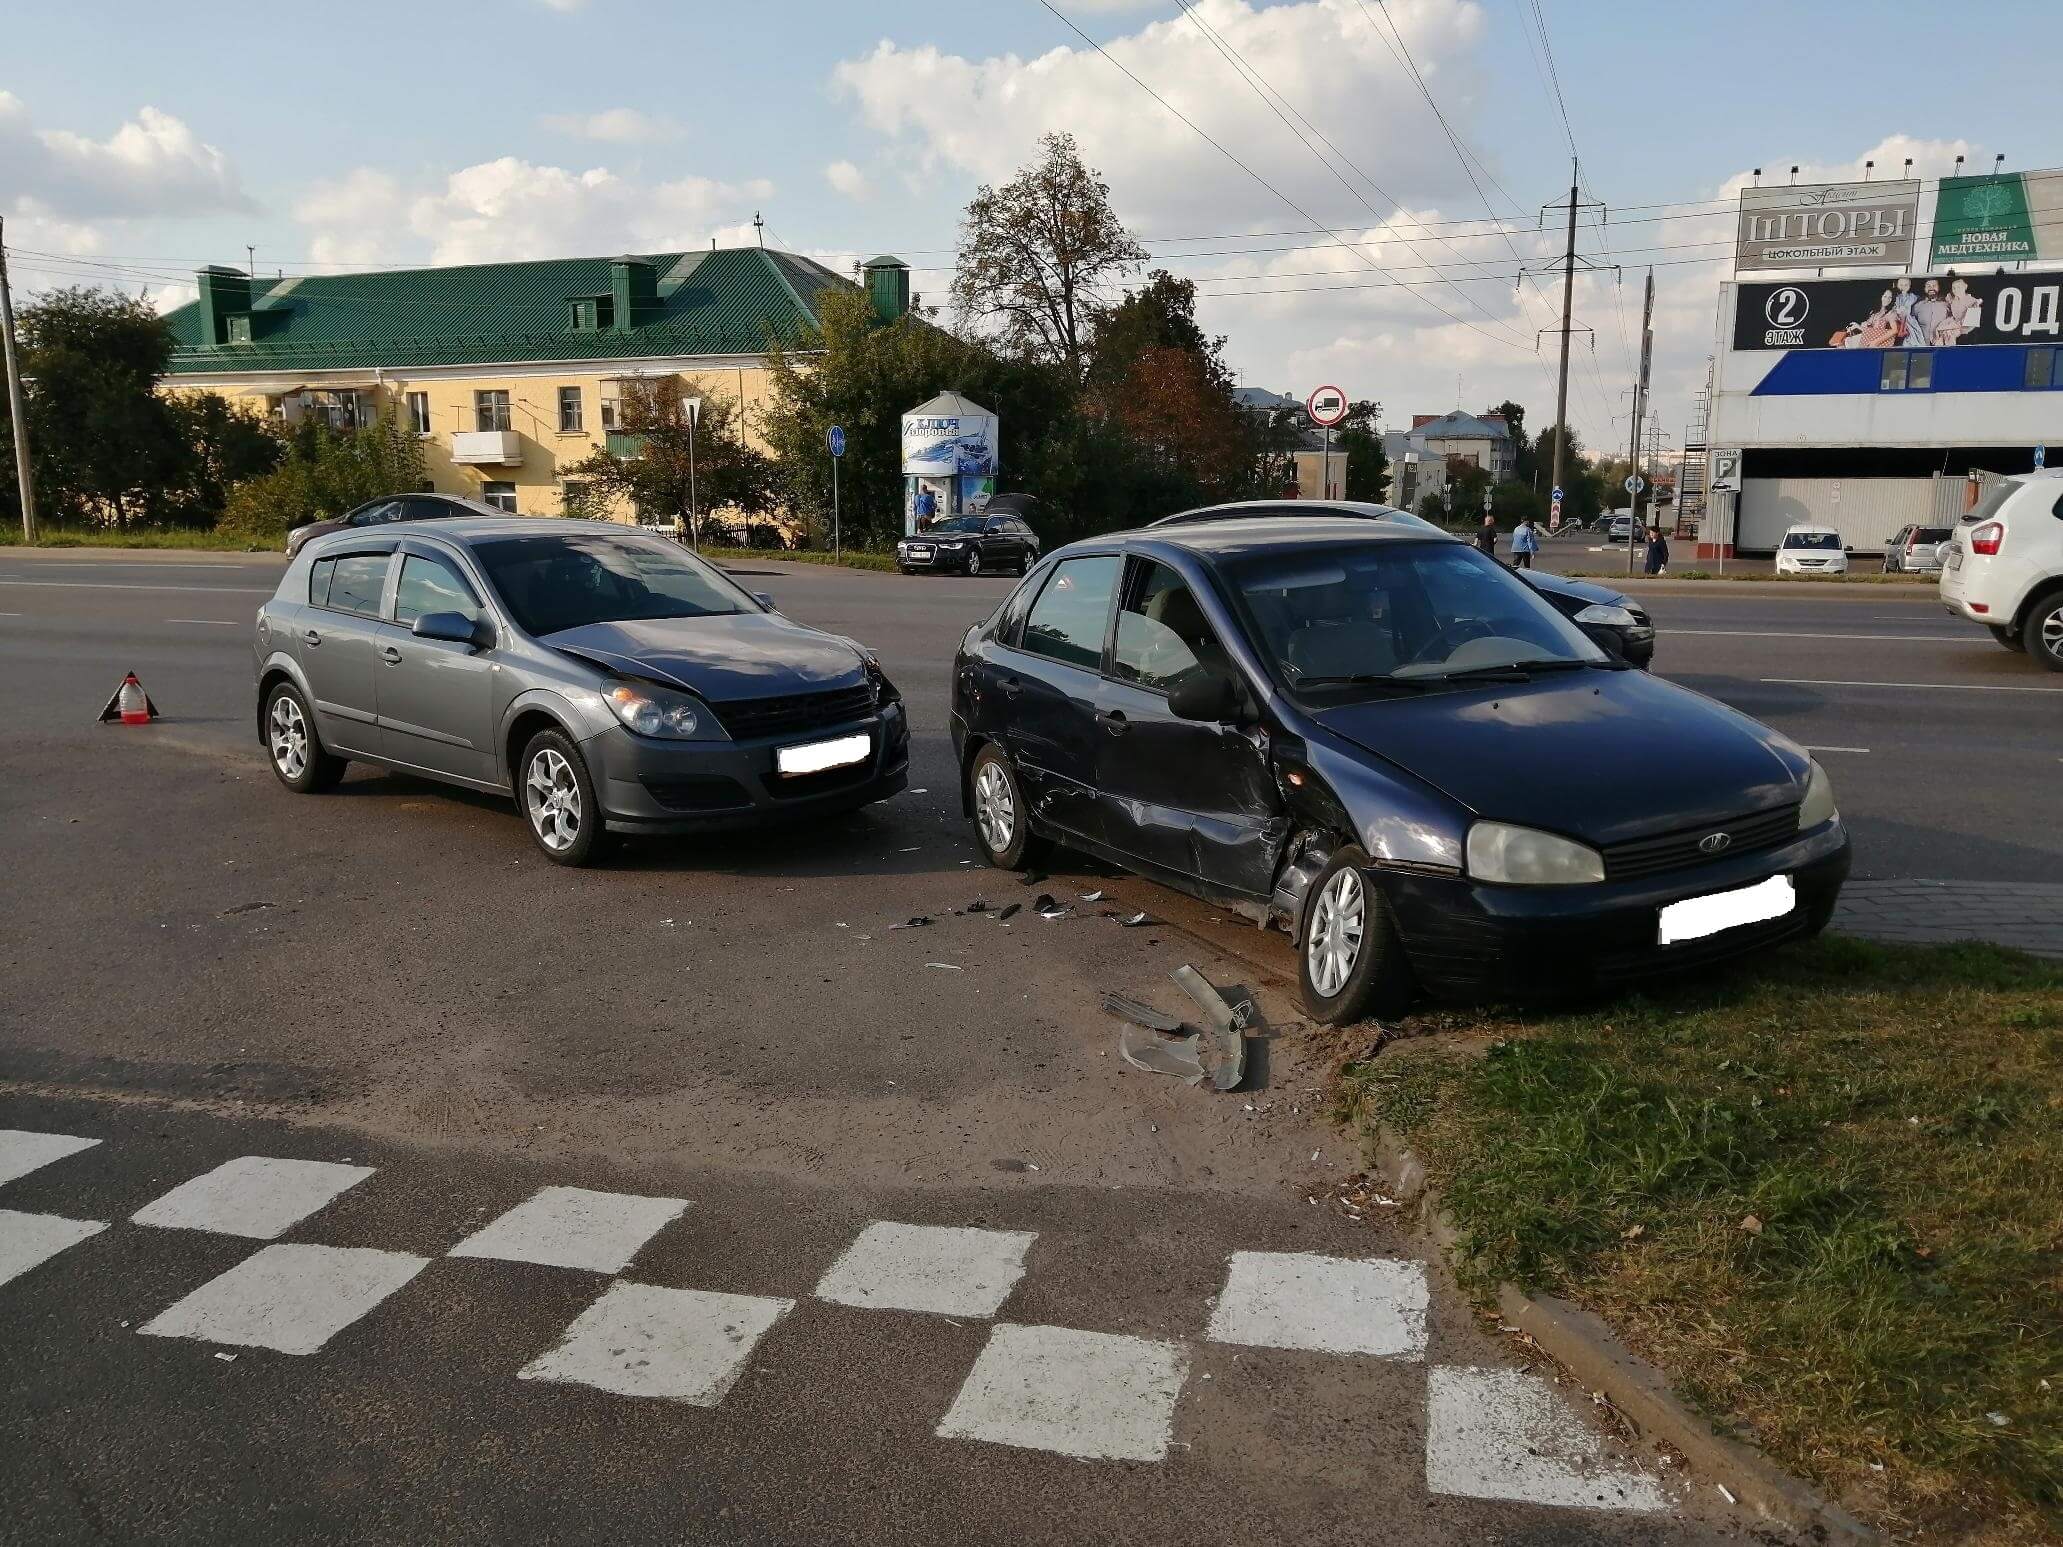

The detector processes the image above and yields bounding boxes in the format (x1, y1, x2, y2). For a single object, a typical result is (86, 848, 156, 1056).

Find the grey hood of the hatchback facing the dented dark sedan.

(538, 613, 866, 703)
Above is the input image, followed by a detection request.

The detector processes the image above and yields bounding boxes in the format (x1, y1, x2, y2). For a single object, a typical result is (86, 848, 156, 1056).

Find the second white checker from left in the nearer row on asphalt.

(138, 1246, 429, 1353)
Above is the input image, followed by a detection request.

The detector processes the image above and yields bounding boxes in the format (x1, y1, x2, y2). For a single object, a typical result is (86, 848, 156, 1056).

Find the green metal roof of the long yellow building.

(167, 248, 858, 375)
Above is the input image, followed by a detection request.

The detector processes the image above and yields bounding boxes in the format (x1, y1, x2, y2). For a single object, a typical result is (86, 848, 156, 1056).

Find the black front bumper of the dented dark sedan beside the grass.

(1370, 823, 1848, 1000)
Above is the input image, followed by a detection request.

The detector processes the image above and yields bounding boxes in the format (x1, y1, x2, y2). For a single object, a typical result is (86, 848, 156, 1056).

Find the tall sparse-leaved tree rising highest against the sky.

(953, 134, 1147, 382)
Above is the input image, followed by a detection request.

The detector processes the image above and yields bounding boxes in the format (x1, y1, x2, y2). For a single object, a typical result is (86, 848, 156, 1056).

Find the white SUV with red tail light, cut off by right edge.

(1941, 468, 2063, 672)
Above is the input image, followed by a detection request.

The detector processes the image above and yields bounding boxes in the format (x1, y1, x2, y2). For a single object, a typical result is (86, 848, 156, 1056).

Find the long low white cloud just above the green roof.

(295, 157, 774, 264)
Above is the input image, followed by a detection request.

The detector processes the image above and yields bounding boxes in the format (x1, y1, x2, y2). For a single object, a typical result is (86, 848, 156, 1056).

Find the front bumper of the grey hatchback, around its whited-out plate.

(582, 703, 910, 833)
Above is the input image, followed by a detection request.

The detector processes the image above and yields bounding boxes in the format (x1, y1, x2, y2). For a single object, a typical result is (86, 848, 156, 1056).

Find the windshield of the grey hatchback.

(472, 532, 747, 637)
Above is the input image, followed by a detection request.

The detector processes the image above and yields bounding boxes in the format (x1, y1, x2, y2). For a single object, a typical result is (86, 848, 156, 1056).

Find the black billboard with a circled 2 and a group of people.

(1733, 268, 2063, 349)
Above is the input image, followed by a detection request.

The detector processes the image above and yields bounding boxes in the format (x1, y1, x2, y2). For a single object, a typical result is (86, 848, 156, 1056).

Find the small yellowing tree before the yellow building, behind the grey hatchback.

(565, 375, 774, 542)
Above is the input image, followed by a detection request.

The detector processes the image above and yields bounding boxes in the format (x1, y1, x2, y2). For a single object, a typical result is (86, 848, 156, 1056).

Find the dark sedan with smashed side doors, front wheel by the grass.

(951, 516, 1848, 1021)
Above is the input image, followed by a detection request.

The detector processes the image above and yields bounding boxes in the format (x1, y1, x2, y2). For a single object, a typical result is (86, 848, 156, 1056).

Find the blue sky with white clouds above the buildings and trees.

(0, 0, 2063, 453)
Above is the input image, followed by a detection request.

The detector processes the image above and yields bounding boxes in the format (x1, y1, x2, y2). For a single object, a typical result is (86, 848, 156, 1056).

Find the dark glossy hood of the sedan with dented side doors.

(1312, 670, 1807, 844)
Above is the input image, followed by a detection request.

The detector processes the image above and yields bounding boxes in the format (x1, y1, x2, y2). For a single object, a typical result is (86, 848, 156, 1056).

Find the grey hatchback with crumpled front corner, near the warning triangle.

(256, 516, 910, 864)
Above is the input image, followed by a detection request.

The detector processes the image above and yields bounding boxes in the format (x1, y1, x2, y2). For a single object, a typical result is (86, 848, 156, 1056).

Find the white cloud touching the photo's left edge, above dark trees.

(0, 91, 256, 217)
